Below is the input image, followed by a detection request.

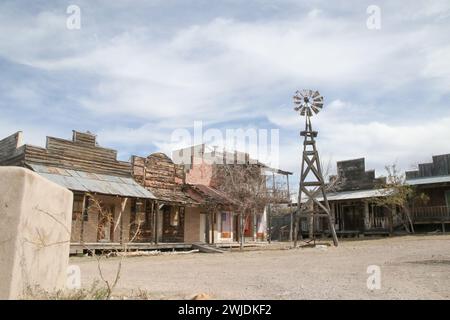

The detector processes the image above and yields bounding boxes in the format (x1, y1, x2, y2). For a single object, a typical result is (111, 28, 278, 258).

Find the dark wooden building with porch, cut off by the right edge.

(406, 154, 450, 232)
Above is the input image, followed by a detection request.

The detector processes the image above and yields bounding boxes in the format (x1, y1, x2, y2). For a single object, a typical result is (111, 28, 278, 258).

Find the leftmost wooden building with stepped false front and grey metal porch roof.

(0, 131, 156, 250)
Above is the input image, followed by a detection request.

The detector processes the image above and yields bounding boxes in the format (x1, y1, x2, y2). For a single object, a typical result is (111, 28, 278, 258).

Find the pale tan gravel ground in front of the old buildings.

(71, 235, 450, 299)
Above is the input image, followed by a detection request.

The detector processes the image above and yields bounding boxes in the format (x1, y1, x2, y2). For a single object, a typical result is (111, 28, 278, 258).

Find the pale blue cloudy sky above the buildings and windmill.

(0, 0, 450, 190)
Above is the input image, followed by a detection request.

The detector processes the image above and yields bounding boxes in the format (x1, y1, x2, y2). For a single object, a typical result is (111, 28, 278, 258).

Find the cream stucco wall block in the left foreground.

(0, 167, 73, 299)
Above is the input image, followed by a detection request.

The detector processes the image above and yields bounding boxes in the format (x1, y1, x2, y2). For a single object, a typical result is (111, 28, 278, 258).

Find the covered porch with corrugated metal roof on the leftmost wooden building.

(28, 164, 156, 248)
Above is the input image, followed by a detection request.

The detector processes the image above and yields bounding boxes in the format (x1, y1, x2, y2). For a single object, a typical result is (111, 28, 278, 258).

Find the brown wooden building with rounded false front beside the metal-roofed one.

(131, 153, 236, 243)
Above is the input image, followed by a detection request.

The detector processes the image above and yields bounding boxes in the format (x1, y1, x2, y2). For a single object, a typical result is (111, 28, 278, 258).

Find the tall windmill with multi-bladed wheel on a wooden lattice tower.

(294, 90, 338, 246)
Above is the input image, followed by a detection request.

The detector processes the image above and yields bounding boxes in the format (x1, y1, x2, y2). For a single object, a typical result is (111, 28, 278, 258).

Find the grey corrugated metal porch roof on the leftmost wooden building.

(28, 164, 156, 199)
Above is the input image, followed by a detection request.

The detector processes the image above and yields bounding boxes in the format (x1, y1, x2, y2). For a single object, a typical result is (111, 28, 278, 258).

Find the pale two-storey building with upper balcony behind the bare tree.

(173, 144, 292, 243)
